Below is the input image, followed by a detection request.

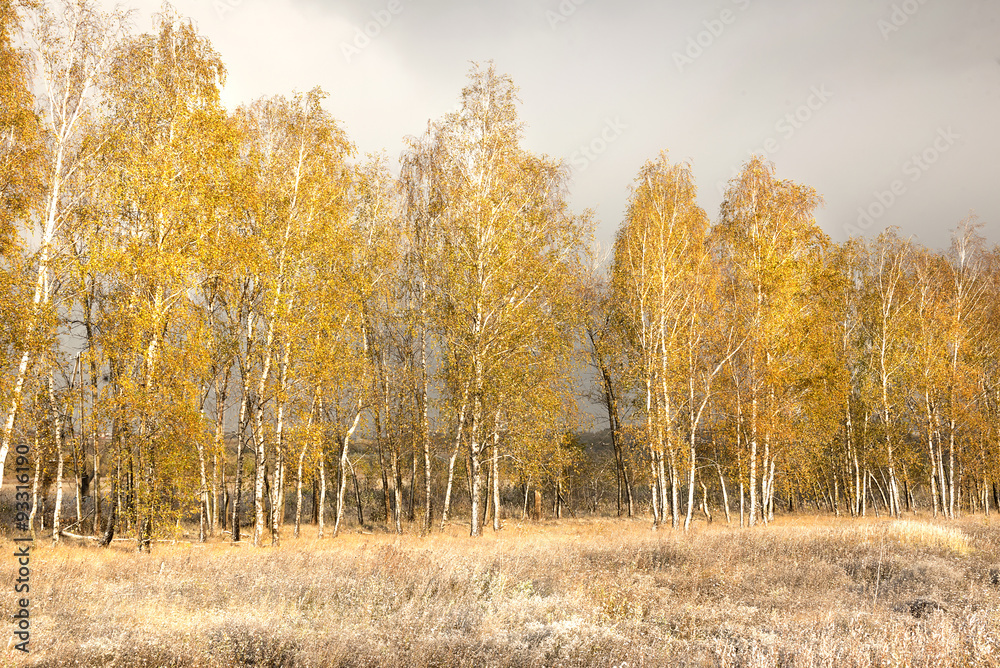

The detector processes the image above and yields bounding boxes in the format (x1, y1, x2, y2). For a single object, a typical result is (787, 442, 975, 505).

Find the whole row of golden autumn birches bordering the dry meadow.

(0, 0, 1000, 550)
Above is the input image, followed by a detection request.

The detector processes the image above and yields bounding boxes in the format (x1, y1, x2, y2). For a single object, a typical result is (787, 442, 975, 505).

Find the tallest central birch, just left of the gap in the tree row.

(418, 64, 589, 536)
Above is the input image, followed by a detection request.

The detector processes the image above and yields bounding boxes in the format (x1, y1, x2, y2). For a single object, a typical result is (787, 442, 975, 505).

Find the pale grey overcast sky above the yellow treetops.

(107, 0, 1000, 254)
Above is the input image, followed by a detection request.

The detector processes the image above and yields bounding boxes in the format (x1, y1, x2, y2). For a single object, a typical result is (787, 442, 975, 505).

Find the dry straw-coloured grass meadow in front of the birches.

(0, 515, 1000, 668)
